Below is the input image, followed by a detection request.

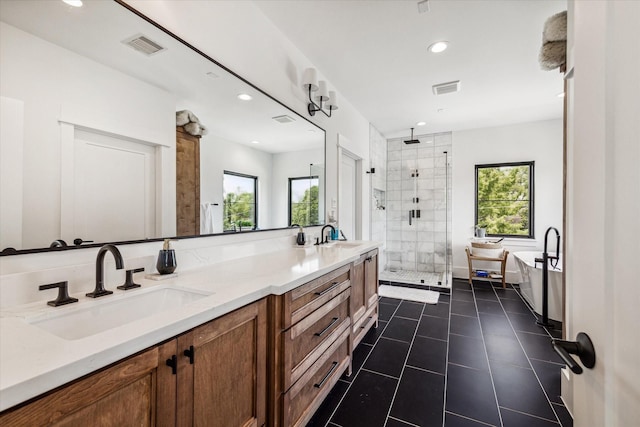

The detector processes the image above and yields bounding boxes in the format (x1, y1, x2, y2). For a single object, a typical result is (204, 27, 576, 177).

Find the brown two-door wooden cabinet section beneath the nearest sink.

(0, 299, 267, 427)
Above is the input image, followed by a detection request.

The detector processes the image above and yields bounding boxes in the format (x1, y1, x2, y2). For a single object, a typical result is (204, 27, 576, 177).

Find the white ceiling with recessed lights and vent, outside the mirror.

(255, 0, 566, 138)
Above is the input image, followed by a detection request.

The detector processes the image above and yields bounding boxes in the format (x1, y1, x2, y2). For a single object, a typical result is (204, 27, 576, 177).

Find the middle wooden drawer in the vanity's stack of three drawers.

(283, 289, 351, 390)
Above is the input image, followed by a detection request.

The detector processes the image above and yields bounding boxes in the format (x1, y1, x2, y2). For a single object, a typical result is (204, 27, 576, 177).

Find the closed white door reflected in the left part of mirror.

(63, 129, 156, 242)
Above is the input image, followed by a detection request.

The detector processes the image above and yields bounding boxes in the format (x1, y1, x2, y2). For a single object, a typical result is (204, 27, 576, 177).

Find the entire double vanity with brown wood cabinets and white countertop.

(0, 241, 378, 426)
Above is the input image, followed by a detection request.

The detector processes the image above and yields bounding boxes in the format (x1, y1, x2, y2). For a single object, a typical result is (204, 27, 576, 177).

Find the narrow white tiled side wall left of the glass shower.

(369, 125, 388, 269)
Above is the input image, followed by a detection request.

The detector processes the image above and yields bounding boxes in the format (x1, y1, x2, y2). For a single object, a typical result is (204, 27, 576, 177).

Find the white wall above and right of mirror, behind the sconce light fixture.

(127, 0, 370, 239)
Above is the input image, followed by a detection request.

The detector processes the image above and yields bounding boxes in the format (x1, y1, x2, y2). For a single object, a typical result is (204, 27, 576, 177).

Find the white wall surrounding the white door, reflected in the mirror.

(0, 23, 175, 248)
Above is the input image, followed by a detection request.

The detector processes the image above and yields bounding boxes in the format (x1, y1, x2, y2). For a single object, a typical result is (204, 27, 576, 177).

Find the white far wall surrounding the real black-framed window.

(452, 119, 563, 282)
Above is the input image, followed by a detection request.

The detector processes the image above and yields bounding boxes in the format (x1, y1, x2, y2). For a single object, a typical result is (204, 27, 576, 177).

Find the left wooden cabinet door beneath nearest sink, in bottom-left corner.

(0, 341, 176, 427)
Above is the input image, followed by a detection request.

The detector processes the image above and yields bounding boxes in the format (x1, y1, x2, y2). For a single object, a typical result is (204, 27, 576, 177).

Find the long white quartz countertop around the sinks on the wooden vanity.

(0, 241, 380, 411)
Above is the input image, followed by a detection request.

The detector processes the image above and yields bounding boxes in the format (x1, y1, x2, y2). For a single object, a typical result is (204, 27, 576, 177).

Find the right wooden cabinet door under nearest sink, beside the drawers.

(178, 300, 267, 427)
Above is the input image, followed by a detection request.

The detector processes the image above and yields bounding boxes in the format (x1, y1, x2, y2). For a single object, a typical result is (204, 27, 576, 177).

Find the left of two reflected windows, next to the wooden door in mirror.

(222, 171, 258, 231)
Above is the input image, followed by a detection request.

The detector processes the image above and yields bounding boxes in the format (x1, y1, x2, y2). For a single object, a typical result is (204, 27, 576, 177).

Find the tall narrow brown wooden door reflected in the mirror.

(176, 126, 200, 236)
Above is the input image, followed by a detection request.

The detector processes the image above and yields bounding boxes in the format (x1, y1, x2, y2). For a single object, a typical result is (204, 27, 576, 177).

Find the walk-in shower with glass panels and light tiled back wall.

(380, 133, 451, 287)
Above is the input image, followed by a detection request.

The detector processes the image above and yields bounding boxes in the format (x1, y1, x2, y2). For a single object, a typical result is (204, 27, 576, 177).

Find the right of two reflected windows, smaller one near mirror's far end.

(289, 176, 320, 225)
